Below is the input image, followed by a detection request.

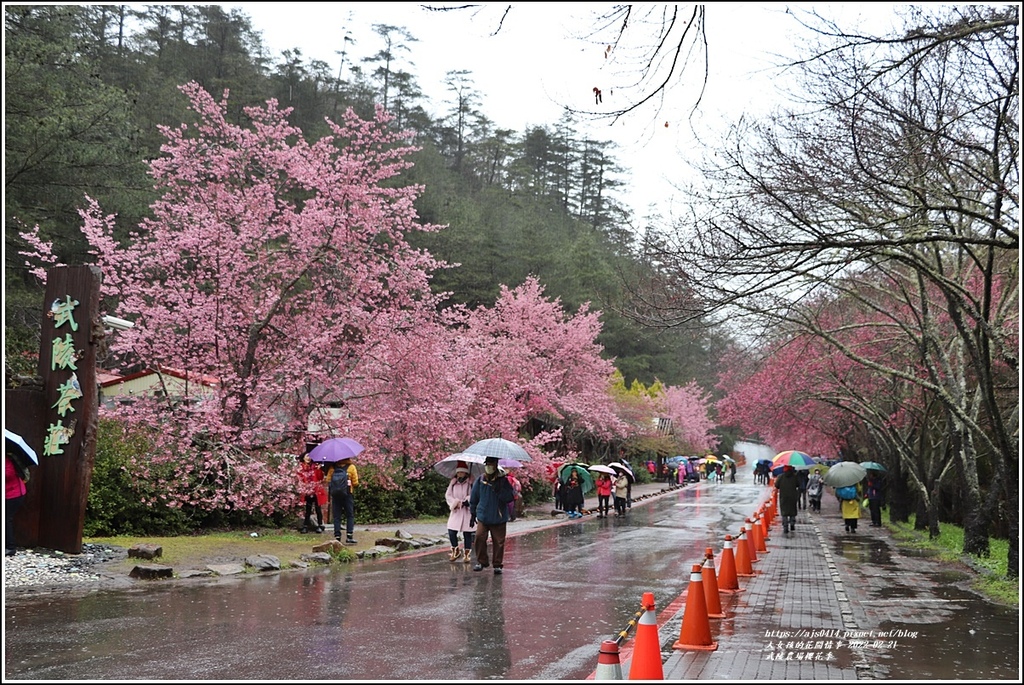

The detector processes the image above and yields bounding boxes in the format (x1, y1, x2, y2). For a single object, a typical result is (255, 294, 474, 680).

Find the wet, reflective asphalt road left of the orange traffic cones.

(5, 483, 764, 680)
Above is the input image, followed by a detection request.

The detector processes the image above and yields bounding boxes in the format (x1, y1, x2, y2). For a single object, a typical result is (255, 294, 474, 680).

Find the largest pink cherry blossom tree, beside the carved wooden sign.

(26, 84, 441, 512)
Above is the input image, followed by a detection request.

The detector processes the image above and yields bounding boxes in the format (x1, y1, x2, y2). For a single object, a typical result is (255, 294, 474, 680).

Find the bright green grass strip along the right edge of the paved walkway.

(884, 510, 1020, 607)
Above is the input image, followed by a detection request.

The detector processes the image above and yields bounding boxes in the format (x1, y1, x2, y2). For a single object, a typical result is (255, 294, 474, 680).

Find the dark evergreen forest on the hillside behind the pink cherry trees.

(4, 5, 723, 391)
